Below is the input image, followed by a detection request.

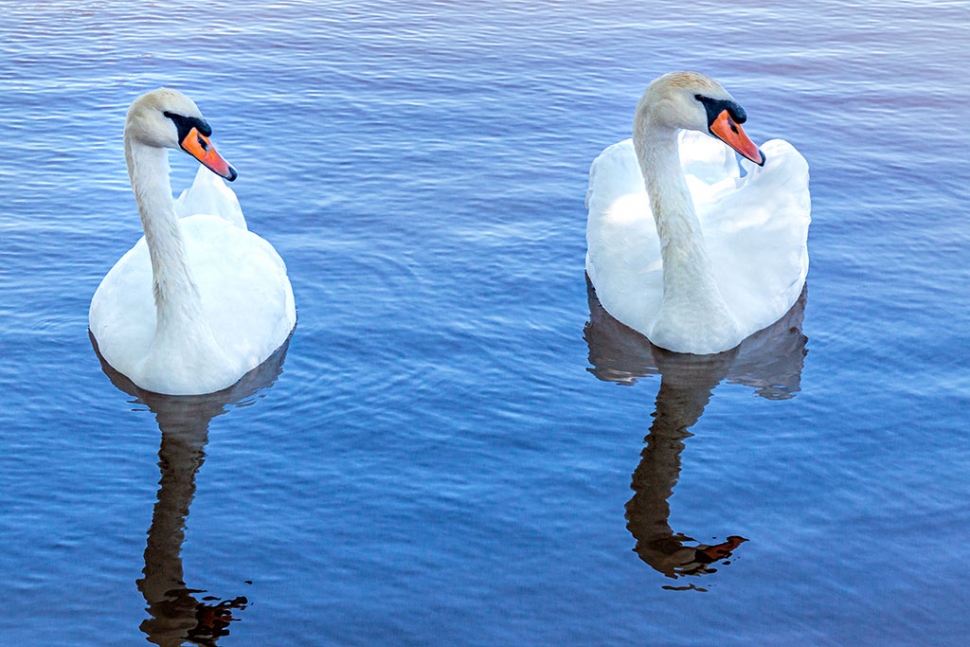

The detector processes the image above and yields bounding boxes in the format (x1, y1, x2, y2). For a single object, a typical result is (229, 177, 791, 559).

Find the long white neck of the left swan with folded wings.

(125, 133, 204, 334)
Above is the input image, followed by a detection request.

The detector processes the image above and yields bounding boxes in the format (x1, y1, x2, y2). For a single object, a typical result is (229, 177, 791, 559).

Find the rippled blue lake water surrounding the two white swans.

(0, 0, 970, 646)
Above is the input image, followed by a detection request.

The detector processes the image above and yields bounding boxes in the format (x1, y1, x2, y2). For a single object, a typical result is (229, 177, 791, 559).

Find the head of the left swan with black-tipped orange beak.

(125, 88, 236, 182)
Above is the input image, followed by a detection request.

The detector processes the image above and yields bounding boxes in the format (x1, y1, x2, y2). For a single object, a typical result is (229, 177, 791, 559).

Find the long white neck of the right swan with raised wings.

(633, 112, 726, 324)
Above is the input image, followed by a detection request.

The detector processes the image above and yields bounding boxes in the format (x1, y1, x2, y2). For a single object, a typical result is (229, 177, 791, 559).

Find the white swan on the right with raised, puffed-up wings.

(586, 72, 811, 355)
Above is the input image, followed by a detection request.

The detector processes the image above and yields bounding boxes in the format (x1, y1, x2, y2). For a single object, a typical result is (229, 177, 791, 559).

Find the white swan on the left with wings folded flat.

(88, 88, 296, 395)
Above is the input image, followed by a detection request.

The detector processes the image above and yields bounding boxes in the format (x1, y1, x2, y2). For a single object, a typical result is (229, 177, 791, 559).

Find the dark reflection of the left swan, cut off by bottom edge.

(89, 333, 290, 647)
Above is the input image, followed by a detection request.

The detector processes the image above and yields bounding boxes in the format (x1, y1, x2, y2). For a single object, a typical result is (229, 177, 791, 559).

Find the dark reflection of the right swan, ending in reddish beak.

(584, 279, 808, 591)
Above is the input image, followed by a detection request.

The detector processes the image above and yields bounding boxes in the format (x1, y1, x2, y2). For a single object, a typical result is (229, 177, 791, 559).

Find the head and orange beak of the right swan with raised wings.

(637, 72, 765, 166)
